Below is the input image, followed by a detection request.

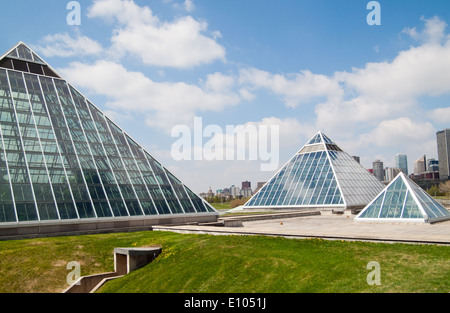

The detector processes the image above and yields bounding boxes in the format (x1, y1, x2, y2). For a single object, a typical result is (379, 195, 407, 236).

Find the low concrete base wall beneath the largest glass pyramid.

(0, 213, 219, 240)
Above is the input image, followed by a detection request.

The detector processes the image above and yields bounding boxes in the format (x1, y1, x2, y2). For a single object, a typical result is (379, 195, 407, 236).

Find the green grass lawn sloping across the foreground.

(0, 232, 450, 293)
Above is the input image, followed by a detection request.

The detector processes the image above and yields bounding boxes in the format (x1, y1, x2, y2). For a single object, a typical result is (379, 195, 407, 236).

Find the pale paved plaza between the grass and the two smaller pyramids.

(154, 214, 450, 245)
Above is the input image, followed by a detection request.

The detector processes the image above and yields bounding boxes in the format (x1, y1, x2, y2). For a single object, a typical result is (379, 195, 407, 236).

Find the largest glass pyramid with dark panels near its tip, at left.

(0, 43, 217, 228)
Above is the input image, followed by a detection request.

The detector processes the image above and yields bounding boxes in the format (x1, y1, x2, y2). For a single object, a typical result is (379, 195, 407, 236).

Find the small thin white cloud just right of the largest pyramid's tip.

(36, 33, 103, 57)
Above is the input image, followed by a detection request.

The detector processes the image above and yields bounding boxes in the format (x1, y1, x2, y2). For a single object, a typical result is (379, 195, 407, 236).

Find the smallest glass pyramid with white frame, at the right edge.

(355, 173, 450, 223)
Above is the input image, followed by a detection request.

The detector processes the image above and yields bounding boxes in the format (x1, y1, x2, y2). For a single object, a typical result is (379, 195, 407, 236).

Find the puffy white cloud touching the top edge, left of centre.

(88, 0, 226, 68)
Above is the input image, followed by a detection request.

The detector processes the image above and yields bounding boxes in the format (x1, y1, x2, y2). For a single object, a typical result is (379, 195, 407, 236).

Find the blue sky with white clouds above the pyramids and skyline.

(0, 0, 450, 192)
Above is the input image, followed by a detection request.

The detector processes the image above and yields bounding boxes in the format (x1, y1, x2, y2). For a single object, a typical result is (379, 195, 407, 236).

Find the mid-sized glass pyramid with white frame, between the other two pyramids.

(244, 132, 383, 209)
